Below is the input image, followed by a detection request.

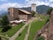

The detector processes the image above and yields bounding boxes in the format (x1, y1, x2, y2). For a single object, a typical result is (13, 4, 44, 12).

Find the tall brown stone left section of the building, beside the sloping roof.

(8, 8, 18, 20)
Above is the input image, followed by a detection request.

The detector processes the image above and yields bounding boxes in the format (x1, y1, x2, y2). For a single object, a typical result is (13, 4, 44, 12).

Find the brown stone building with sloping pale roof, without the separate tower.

(8, 8, 31, 21)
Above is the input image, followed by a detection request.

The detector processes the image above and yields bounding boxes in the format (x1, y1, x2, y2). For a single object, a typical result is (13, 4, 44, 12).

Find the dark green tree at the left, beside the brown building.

(0, 15, 11, 32)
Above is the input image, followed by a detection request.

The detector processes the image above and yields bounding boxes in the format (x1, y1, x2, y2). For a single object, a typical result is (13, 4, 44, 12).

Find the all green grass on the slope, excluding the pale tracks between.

(0, 15, 49, 40)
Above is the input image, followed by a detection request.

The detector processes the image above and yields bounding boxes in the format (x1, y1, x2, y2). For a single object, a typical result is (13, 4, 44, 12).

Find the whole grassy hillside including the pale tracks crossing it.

(0, 14, 48, 40)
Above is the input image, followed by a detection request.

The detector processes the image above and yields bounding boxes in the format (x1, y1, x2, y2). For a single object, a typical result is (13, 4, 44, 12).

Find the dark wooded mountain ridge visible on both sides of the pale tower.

(19, 5, 51, 14)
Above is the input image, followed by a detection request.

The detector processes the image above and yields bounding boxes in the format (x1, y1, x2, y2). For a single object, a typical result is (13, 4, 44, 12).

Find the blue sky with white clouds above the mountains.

(0, 0, 53, 11)
